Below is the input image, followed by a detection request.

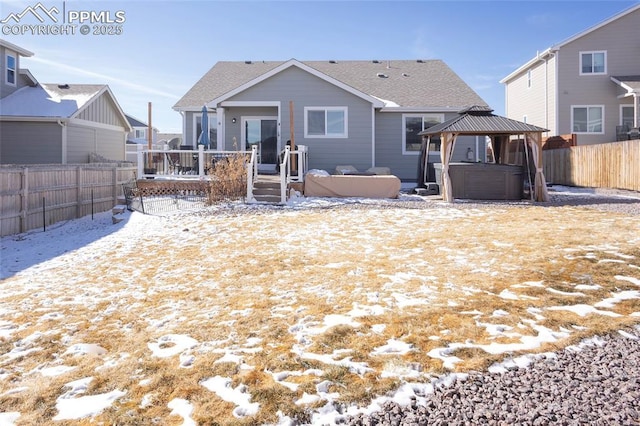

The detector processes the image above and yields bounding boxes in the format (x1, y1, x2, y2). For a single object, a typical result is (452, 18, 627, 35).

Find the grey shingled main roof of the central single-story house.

(174, 59, 486, 110)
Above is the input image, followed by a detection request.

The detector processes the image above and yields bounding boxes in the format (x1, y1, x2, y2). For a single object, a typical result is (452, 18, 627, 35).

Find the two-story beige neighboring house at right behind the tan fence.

(500, 4, 640, 145)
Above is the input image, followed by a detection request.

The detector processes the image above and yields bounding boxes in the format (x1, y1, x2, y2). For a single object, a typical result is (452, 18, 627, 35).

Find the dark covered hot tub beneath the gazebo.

(434, 162, 524, 200)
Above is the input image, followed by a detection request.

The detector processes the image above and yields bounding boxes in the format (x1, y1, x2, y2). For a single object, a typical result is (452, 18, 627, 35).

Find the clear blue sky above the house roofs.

(0, 0, 638, 132)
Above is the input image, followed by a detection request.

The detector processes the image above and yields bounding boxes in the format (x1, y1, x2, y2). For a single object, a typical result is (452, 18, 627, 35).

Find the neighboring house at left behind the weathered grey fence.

(0, 40, 131, 164)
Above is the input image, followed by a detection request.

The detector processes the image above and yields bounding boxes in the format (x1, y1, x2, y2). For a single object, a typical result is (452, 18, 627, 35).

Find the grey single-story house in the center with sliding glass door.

(174, 59, 486, 181)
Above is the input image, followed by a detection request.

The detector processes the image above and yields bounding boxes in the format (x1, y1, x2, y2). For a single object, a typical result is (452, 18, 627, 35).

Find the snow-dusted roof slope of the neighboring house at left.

(0, 84, 107, 118)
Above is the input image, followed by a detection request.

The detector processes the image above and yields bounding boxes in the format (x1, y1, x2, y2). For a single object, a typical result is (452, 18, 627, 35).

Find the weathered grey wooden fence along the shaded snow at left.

(0, 164, 136, 236)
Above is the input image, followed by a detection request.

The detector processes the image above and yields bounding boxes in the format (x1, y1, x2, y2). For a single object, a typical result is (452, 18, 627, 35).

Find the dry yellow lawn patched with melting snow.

(0, 197, 640, 425)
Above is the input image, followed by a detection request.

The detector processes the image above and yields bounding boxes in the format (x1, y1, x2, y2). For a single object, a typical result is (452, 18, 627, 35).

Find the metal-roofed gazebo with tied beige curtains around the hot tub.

(418, 106, 549, 202)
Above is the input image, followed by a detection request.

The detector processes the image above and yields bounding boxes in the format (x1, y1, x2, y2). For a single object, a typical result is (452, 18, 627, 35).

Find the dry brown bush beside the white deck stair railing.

(209, 153, 247, 204)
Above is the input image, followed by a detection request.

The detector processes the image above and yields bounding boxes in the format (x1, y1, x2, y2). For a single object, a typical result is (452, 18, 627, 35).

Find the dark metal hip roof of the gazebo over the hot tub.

(418, 106, 549, 136)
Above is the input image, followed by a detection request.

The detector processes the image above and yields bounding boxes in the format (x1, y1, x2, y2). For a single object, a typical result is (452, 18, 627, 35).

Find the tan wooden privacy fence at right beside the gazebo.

(543, 140, 640, 191)
